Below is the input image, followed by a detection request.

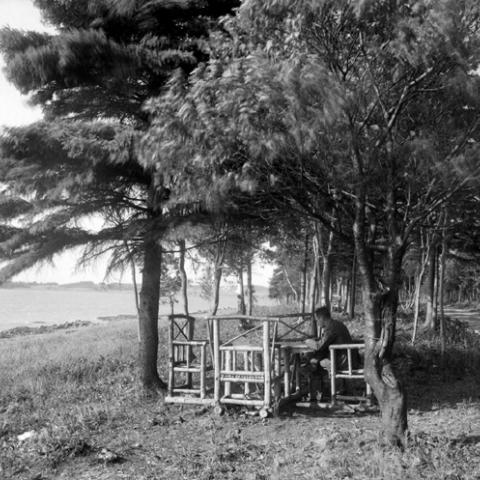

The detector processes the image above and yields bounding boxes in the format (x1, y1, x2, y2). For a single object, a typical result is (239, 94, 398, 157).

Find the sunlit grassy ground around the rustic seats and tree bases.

(0, 310, 480, 480)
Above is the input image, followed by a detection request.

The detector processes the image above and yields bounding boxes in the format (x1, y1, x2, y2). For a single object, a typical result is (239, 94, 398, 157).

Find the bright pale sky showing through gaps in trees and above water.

(0, 0, 272, 285)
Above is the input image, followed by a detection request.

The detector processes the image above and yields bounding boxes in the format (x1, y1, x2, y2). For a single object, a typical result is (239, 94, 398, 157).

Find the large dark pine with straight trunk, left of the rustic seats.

(0, 0, 237, 389)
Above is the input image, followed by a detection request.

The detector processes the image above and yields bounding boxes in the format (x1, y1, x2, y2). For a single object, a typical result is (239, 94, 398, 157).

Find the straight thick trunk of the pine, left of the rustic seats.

(138, 232, 166, 390)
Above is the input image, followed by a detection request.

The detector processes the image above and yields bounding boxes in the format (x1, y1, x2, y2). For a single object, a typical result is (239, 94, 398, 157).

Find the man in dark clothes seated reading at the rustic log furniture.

(305, 307, 360, 396)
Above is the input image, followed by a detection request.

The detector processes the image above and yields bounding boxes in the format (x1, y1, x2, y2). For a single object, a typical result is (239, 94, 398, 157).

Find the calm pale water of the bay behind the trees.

(0, 288, 272, 330)
